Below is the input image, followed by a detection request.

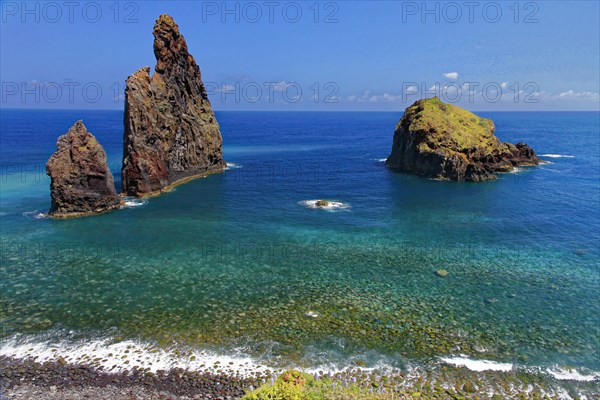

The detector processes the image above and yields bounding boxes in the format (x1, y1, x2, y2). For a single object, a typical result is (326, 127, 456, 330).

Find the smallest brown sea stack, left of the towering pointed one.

(46, 121, 120, 217)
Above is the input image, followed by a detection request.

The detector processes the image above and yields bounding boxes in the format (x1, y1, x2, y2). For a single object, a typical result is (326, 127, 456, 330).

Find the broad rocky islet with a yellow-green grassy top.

(386, 97, 540, 182)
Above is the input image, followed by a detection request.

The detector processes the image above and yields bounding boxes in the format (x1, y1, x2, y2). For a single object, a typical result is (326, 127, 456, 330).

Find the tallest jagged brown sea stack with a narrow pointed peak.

(122, 15, 226, 196)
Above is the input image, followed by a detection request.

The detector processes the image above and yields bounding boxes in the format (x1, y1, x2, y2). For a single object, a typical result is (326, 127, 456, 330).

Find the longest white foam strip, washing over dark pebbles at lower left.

(0, 338, 272, 376)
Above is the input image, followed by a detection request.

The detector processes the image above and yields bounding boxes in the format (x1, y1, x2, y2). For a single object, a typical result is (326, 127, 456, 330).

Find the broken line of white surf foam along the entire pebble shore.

(0, 336, 600, 398)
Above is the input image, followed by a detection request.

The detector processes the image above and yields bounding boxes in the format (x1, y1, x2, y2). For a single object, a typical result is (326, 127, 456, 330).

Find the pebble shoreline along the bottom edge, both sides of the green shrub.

(0, 356, 600, 400)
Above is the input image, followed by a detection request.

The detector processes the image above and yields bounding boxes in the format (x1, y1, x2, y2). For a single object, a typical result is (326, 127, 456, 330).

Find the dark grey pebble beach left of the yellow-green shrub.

(0, 357, 253, 400)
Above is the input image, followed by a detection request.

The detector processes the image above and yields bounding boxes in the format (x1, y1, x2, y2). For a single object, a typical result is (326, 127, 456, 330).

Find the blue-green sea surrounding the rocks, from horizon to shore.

(0, 110, 600, 388)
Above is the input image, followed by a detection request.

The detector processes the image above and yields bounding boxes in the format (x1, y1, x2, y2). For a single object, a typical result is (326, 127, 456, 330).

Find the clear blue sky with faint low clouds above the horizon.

(0, 0, 600, 111)
